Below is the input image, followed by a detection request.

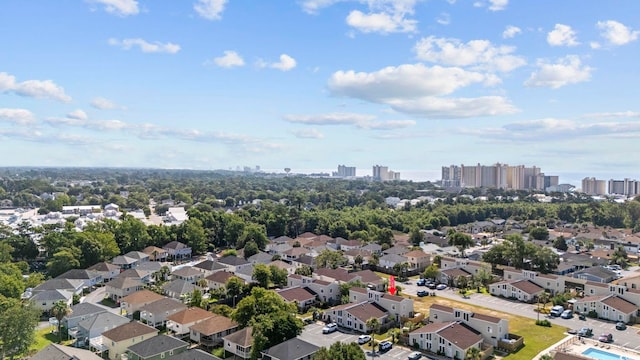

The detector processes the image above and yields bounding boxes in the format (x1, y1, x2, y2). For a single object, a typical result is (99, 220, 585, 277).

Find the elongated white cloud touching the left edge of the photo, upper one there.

(0, 72, 71, 102)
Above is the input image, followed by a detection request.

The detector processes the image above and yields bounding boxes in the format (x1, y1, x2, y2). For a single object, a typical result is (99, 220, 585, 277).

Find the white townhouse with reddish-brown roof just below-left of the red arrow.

(324, 301, 390, 333)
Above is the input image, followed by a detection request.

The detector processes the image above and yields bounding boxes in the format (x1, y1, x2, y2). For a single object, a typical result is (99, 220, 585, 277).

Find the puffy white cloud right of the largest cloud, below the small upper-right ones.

(524, 55, 593, 89)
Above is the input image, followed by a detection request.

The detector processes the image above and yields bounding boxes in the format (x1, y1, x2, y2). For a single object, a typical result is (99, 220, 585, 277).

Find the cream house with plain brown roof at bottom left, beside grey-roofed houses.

(102, 321, 158, 360)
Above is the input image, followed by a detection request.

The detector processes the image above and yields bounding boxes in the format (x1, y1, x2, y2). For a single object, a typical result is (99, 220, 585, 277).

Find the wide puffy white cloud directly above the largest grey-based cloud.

(414, 36, 526, 72)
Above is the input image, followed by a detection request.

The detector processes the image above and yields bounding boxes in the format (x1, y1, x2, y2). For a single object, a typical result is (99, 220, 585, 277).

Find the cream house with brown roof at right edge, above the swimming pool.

(573, 294, 638, 323)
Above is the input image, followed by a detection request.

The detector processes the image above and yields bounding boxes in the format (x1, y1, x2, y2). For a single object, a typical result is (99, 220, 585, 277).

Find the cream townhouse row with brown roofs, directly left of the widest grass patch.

(409, 304, 509, 359)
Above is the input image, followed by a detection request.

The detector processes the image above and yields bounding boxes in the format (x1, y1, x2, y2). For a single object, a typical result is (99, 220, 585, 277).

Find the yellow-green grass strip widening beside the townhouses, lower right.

(413, 297, 567, 360)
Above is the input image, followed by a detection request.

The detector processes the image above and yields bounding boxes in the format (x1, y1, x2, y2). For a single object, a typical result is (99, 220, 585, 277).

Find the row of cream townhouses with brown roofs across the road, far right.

(489, 268, 640, 322)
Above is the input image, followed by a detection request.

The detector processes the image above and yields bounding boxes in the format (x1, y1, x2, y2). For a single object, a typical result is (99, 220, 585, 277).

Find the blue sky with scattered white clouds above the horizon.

(0, 0, 640, 182)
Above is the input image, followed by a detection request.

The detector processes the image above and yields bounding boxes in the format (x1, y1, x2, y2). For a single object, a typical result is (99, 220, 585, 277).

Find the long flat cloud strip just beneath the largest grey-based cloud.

(389, 96, 519, 119)
